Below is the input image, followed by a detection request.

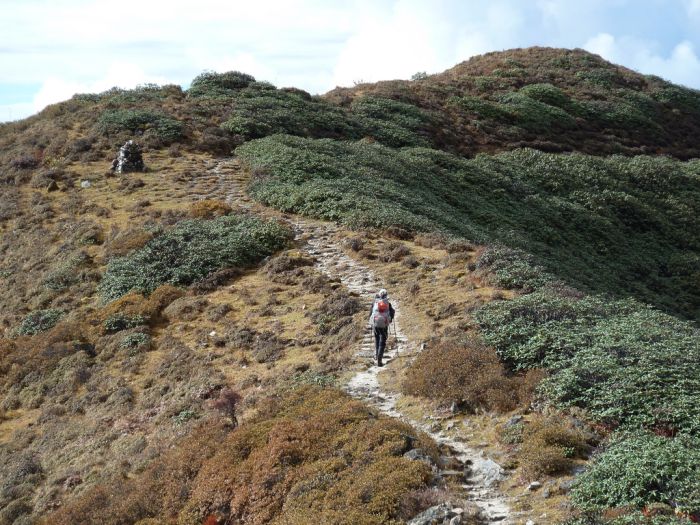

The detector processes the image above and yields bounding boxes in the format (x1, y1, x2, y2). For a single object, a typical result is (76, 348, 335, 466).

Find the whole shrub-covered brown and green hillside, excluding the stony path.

(0, 48, 700, 525)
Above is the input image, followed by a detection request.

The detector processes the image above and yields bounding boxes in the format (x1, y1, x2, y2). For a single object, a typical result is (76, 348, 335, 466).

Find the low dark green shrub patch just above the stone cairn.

(97, 109, 184, 143)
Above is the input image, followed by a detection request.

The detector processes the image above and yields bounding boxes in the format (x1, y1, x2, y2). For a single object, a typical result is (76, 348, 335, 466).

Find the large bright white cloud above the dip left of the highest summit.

(333, 0, 524, 86)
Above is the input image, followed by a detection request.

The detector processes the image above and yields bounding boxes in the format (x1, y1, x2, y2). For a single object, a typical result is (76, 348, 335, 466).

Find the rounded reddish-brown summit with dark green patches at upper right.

(326, 47, 700, 159)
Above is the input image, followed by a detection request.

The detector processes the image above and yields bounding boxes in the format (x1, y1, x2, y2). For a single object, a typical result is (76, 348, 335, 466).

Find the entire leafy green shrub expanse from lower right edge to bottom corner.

(477, 278, 700, 523)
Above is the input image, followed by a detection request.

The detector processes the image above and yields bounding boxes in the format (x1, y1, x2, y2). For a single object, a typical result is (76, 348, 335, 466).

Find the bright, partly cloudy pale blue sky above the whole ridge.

(0, 0, 700, 122)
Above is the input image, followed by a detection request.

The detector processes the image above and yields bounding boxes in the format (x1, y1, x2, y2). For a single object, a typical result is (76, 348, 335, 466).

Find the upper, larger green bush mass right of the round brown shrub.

(477, 293, 700, 435)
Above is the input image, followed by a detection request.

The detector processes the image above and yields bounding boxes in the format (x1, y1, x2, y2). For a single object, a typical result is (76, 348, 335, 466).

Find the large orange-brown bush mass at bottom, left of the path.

(49, 387, 437, 525)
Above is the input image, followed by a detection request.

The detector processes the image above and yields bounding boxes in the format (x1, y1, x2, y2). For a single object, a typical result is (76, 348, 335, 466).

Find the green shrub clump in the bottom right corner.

(571, 432, 700, 513)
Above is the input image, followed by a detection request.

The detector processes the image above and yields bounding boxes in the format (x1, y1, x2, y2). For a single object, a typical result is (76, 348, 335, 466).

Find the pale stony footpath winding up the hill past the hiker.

(193, 158, 513, 525)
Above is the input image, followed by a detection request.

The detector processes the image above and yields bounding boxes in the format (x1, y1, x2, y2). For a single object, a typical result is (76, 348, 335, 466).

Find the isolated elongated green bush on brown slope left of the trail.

(99, 215, 289, 301)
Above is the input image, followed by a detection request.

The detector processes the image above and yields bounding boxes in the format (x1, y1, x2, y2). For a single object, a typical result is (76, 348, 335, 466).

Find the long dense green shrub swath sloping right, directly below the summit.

(237, 136, 700, 318)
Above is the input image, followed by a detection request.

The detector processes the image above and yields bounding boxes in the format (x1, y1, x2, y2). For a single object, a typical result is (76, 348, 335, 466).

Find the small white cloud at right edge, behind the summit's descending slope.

(584, 33, 700, 86)
